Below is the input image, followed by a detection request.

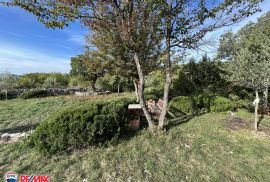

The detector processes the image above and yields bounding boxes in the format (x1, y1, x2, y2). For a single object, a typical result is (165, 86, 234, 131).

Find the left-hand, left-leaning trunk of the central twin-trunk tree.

(134, 53, 155, 130)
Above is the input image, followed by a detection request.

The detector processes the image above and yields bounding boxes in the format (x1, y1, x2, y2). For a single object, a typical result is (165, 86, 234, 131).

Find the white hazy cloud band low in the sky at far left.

(0, 44, 70, 74)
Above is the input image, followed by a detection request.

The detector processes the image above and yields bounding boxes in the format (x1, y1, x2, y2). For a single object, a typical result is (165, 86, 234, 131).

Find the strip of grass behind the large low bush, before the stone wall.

(0, 93, 130, 133)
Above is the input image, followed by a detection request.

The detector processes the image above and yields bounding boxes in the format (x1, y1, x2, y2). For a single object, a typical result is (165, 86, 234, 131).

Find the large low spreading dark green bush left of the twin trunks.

(30, 99, 131, 154)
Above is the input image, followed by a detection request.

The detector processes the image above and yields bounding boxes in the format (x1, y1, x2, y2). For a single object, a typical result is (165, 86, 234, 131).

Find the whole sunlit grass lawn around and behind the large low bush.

(0, 95, 270, 182)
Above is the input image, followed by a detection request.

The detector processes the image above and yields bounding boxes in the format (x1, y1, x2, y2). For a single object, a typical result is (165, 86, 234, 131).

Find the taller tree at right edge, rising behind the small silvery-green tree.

(218, 13, 270, 107)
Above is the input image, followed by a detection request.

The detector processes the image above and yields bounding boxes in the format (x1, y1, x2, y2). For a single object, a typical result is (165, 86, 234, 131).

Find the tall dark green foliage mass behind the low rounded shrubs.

(173, 55, 226, 95)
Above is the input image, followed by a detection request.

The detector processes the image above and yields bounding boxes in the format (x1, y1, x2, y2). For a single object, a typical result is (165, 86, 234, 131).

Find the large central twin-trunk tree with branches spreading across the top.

(6, 0, 261, 129)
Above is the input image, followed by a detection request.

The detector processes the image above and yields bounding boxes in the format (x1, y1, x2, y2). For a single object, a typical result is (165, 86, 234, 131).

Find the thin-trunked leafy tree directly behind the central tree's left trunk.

(87, 27, 160, 102)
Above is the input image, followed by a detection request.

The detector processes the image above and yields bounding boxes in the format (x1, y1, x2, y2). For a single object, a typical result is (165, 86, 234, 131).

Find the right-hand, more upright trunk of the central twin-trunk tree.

(158, 13, 172, 129)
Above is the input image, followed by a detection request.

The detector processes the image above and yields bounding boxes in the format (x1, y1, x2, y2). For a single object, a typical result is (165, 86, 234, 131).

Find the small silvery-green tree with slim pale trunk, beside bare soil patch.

(224, 47, 270, 131)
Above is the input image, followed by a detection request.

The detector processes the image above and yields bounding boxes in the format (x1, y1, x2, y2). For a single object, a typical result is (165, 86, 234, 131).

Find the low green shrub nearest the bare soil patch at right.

(210, 96, 235, 112)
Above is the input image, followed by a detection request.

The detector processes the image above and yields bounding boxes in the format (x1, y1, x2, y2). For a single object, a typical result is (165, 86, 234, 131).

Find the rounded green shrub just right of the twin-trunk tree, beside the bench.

(169, 96, 197, 114)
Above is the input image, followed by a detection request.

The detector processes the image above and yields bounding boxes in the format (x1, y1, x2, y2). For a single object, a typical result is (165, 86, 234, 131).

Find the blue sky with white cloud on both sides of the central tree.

(0, 0, 270, 74)
